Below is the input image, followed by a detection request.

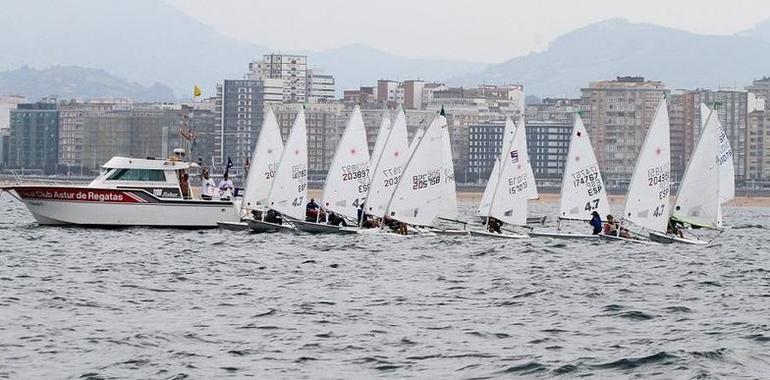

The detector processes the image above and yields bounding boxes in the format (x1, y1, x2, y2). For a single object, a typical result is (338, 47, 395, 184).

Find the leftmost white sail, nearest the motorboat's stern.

(243, 107, 283, 209)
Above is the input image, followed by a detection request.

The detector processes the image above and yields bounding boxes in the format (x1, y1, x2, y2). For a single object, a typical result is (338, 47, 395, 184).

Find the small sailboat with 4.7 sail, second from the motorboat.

(248, 109, 307, 232)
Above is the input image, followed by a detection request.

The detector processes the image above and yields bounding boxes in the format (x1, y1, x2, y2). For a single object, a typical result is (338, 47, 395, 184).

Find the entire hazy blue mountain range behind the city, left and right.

(0, 0, 770, 100)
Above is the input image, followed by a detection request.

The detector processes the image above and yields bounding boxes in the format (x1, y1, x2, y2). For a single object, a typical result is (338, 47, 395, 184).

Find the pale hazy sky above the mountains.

(169, 0, 770, 62)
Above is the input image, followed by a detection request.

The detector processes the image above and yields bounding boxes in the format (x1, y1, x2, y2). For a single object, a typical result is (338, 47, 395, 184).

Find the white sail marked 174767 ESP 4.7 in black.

(559, 115, 610, 220)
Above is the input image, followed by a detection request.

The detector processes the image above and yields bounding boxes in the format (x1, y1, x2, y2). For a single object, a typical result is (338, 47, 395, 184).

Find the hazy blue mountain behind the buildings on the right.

(450, 19, 770, 96)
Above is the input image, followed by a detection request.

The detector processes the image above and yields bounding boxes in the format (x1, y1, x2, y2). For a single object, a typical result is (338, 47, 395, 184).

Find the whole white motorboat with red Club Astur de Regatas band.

(3, 157, 238, 228)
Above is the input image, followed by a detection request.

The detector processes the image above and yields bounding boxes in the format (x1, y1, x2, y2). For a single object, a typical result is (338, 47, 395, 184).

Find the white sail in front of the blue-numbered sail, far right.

(671, 107, 722, 228)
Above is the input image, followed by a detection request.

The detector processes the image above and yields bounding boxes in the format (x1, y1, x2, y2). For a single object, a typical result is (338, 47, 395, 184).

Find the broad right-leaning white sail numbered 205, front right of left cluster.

(387, 116, 446, 226)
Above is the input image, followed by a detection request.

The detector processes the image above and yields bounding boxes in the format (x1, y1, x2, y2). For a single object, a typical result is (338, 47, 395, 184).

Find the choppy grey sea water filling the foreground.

(0, 196, 770, 379)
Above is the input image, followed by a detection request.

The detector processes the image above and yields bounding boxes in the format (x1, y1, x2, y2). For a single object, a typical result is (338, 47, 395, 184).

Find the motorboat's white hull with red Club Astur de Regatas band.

(5, 186, 239, 228)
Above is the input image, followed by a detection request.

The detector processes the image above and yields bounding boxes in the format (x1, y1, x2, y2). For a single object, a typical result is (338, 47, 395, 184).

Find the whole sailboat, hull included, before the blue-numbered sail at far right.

(650, 104, 722, 245)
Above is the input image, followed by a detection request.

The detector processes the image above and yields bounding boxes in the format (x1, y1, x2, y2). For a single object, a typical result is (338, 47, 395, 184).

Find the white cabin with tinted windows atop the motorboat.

(88, 157, 198, 199)
